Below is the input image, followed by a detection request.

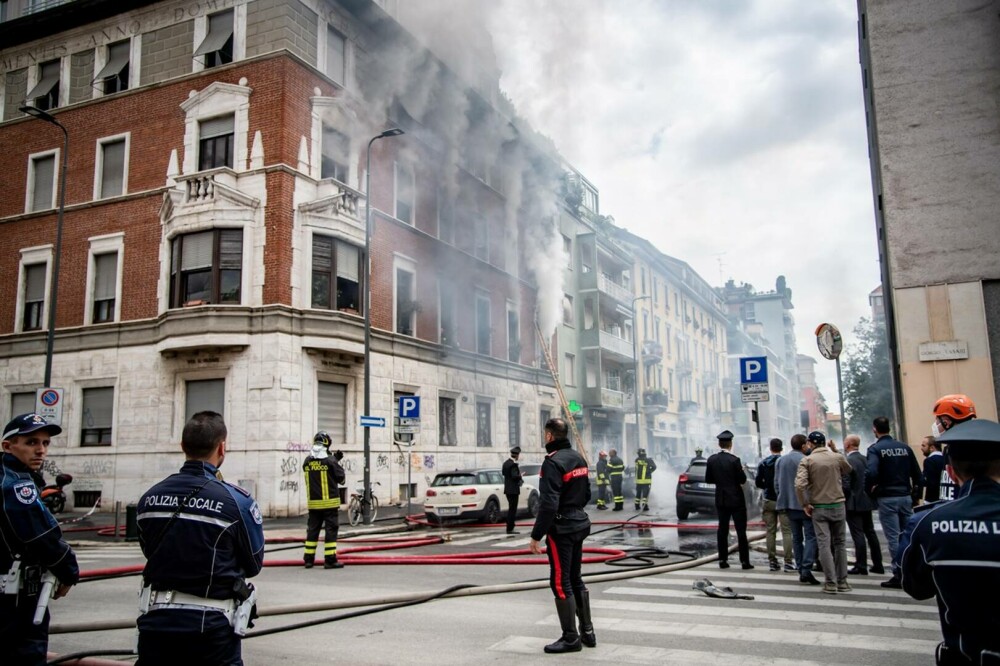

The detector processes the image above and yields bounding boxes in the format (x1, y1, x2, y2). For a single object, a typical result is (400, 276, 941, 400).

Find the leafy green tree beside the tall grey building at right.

(843, 317, 893, 433)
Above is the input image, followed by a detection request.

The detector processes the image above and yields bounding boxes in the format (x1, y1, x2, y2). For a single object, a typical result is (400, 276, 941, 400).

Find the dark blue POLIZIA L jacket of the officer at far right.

(900, 478, 1000, 664)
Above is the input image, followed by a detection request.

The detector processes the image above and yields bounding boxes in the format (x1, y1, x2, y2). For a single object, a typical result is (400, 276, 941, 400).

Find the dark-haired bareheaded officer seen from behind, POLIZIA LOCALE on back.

(136, 412, 264, 666)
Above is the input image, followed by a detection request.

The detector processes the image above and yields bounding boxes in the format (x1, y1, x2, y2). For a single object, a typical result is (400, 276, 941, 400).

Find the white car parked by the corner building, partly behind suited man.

(424, 468, 538, 524)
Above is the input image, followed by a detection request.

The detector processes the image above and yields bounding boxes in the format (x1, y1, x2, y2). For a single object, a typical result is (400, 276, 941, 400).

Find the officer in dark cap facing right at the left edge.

(0, 414, 80, 666)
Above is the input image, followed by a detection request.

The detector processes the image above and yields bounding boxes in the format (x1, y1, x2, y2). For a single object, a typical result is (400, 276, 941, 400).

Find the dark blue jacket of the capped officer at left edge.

(0, 453, 80, 585)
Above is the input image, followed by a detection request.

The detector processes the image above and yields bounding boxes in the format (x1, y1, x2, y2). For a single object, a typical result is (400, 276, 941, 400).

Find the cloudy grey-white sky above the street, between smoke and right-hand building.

(485, 0, 879, 412)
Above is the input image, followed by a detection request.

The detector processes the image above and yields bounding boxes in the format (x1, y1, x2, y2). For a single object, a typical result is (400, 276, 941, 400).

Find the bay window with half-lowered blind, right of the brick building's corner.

(312, 236, 361, 314)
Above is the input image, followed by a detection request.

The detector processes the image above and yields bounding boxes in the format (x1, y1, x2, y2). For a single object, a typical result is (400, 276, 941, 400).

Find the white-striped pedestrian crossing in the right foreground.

(491, 565, 940, 666)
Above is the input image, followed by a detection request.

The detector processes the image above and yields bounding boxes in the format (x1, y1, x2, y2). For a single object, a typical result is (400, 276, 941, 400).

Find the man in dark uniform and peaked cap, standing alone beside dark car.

(705, 430, 753, 569)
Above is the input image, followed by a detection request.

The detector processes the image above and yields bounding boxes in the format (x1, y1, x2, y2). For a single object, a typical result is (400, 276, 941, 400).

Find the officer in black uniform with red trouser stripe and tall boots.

(529, 418, 592, 653)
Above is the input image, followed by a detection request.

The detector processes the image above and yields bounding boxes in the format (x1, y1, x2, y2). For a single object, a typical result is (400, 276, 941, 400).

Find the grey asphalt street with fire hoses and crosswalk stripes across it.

(50, 500, 940, 666)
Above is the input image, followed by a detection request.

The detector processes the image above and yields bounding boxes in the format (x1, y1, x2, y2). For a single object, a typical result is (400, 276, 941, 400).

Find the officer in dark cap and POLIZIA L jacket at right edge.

(900, 419, 1000, 666)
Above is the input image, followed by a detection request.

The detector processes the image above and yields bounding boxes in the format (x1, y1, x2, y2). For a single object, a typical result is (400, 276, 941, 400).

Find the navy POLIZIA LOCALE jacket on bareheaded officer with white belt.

(137, 460, 264, 631)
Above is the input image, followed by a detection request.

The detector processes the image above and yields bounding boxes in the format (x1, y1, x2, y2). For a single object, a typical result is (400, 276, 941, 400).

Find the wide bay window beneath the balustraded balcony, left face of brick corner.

(170, 229, 243, 308)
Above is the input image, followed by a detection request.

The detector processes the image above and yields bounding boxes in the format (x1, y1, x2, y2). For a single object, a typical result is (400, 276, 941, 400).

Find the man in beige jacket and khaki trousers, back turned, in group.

(795, 432, 851, 594)
